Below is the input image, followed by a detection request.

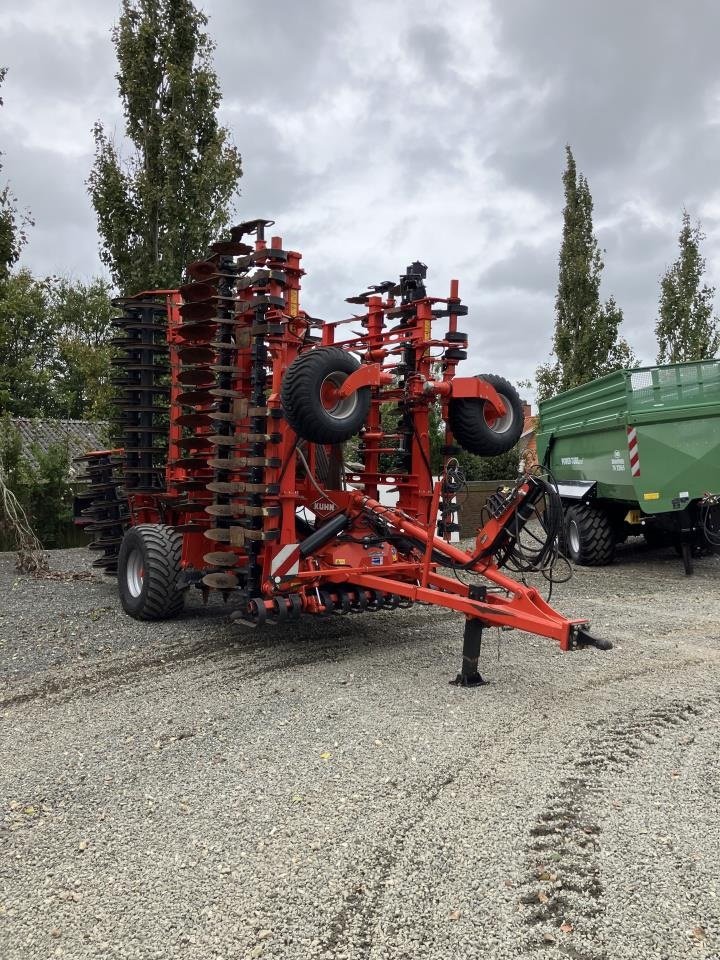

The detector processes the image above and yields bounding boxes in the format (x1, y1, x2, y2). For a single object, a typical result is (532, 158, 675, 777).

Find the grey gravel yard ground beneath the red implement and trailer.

(0, 545, 720, 960)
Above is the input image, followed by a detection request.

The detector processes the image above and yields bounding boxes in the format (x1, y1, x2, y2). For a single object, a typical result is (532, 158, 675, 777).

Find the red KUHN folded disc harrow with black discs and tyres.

(79, 220, 609, 684)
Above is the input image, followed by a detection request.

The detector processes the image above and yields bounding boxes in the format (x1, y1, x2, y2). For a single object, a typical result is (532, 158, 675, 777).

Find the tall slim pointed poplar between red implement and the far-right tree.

(536, 147, 635, 400)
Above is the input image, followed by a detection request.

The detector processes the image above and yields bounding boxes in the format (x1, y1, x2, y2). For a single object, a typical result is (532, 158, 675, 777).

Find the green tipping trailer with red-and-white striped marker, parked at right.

(537, 360, 720, 573)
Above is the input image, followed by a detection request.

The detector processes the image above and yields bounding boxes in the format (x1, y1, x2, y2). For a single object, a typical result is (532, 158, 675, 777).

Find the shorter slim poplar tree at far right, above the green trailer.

(655, 210, 720, 363)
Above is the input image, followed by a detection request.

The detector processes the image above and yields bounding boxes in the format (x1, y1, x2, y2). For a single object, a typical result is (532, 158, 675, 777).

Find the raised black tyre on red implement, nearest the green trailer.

(448, 373, 525, 457)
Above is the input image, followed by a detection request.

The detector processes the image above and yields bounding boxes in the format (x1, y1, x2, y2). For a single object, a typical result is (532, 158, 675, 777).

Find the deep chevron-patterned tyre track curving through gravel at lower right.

(520, 697, 718, 960)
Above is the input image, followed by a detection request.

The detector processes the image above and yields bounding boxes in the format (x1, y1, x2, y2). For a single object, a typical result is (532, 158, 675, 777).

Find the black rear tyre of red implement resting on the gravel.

(118, 523, 185, 620)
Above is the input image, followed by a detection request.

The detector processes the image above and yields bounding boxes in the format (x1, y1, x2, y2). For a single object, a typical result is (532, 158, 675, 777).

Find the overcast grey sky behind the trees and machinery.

(0, 0, 720, 398)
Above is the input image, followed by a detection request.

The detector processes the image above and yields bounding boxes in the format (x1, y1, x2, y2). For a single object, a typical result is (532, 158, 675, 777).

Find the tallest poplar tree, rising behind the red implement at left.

(88, 0, 242, 294)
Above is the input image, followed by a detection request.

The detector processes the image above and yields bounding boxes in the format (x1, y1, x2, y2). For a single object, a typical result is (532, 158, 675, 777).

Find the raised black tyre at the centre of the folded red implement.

(280, 347, 370, 443)
